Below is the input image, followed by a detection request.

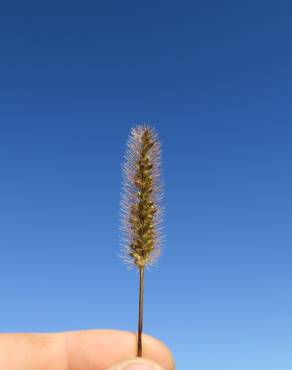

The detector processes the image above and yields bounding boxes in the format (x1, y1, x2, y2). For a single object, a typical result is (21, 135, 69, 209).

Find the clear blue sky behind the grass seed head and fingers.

(0, 0, 292, 370)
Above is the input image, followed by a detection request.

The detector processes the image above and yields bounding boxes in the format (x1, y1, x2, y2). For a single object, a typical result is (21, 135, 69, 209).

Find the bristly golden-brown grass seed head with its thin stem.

(121, 125, 162, 356)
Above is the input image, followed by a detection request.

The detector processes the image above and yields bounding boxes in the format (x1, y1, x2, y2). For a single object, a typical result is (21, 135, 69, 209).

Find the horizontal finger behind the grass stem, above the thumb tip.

(0, 330, 174, 370)
